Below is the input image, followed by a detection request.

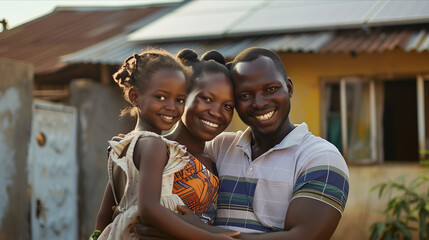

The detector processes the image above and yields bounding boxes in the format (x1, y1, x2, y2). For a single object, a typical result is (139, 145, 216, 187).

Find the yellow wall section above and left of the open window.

(280, 50, 429, 136)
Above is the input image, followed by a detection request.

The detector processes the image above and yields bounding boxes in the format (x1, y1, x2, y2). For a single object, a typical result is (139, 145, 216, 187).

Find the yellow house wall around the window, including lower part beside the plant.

(274, 50, 429, 240)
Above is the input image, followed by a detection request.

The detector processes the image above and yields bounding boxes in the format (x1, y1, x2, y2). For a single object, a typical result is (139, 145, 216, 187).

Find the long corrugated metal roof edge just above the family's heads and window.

(62, 25, 429, 65)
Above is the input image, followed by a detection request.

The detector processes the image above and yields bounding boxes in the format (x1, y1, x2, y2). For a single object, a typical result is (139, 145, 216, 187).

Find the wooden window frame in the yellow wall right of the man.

(320, 73, 429, 164)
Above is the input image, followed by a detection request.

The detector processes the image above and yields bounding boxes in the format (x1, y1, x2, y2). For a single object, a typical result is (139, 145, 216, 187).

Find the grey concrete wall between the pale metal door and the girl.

(70, 79, 135, 239)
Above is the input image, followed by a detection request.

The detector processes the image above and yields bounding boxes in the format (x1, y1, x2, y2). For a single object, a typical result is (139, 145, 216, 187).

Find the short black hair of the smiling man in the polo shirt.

(231, 47, 287, 81)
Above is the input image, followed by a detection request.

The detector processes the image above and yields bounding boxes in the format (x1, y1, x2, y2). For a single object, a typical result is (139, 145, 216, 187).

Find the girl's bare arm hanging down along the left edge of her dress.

(94, 182, 116, 232)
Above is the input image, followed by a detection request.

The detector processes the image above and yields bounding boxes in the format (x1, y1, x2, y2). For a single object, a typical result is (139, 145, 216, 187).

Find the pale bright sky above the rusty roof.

(0, 0, 177, 29)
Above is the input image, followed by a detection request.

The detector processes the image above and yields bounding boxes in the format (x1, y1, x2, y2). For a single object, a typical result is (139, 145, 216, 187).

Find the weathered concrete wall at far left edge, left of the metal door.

(0, 59, 33, 240)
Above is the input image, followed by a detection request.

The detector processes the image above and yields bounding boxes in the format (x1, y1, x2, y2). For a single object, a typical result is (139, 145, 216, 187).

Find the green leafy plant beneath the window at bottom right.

(370, 171, 429, 240)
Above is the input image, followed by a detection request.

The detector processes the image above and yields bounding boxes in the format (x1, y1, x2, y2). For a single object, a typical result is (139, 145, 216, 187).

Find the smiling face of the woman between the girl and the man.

(182, 73, 234, 141)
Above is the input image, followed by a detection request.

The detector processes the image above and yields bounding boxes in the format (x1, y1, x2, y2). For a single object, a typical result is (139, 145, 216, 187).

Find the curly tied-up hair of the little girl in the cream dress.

(113, 48, 187, 116)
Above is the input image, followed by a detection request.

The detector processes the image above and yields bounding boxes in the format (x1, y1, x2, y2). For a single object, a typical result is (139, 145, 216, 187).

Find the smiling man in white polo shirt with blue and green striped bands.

(137, 48, 349, 240)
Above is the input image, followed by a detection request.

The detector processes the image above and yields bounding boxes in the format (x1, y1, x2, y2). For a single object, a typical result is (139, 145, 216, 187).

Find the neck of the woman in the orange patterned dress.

(165, 120, 206, 155)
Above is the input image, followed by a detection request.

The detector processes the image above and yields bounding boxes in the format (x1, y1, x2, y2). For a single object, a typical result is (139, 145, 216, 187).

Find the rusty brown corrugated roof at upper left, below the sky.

(0, 3, 177, 74)
